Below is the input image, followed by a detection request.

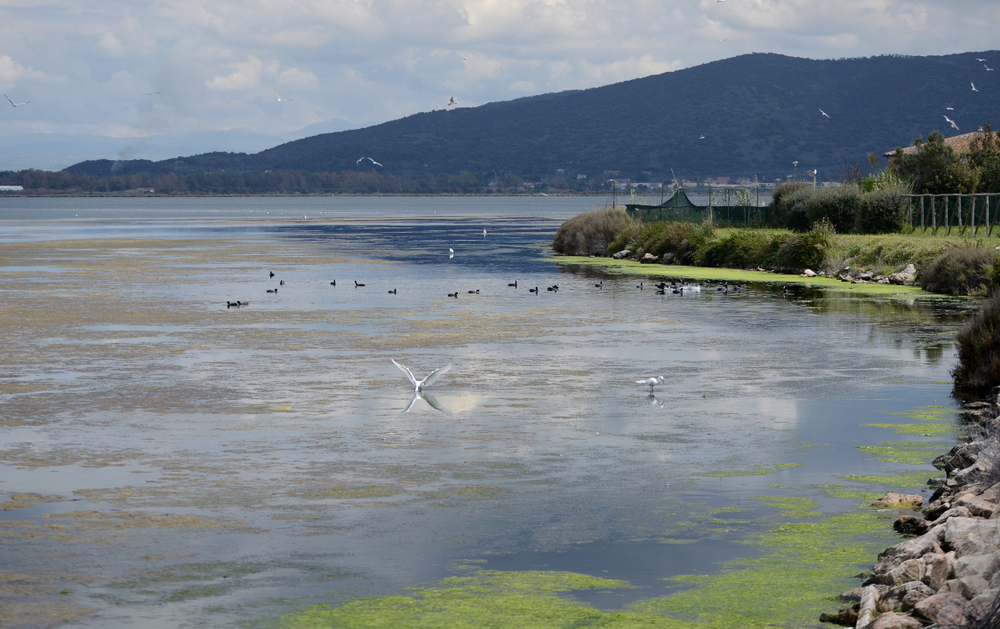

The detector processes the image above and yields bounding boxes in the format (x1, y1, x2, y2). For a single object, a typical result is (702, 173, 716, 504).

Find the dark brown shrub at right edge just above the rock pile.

(951, 292, 1000, 398)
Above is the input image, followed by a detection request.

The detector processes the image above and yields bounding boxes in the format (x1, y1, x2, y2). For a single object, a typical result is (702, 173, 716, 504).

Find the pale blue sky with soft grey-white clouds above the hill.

(0, 0, 1000, 170)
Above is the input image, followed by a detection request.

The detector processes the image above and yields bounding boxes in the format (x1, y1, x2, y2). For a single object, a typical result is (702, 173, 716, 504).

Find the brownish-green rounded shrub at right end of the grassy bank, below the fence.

(919, 246, 1000, 296)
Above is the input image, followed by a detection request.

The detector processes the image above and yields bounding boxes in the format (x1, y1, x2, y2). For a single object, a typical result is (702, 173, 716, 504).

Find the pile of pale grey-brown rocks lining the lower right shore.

(820, 387, 1000, 629)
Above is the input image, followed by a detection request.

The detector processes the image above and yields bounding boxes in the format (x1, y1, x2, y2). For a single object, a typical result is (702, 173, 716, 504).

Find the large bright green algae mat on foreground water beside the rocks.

(278, 496, 894, 629)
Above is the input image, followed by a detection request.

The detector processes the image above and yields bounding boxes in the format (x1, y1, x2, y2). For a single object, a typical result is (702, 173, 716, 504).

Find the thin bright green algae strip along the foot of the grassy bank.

(554, 256, 932, 297)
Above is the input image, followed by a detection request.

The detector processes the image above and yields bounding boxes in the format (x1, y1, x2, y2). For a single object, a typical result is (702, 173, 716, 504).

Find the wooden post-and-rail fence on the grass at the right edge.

(905, 193, 1000, 236)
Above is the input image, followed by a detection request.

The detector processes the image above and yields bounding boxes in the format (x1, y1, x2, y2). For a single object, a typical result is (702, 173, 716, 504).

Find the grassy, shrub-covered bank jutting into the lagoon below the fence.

(552, 208, 1000, 295)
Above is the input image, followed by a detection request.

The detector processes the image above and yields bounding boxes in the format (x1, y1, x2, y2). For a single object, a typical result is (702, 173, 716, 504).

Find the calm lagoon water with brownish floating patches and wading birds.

(0, 197, 967, 627)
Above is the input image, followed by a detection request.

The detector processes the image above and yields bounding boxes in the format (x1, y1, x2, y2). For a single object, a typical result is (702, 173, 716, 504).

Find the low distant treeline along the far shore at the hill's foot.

(0, 170, 600, 195)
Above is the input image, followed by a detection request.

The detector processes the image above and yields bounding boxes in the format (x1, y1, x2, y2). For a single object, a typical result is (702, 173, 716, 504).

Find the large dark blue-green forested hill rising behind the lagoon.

(66, 51, 1000, 181)
